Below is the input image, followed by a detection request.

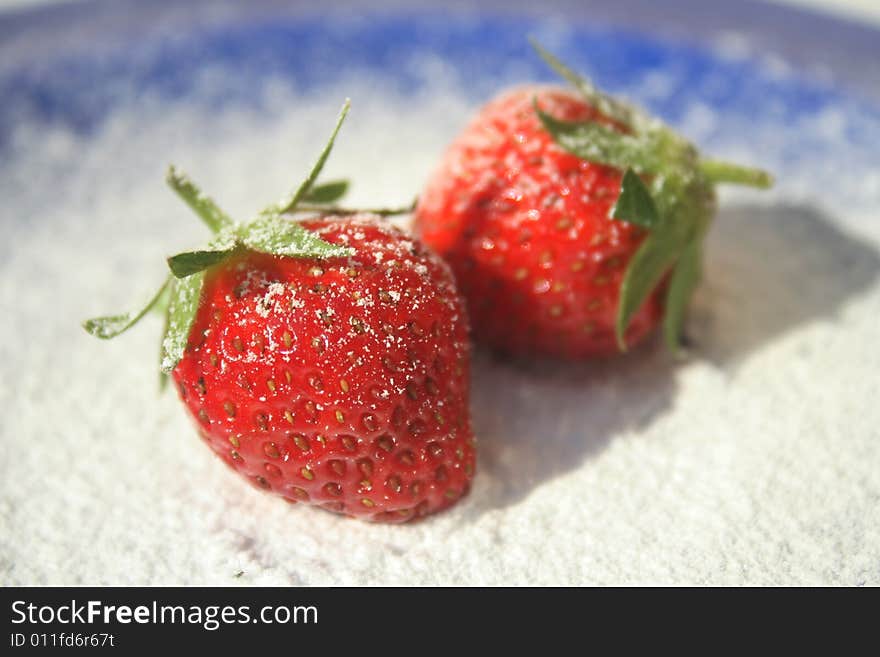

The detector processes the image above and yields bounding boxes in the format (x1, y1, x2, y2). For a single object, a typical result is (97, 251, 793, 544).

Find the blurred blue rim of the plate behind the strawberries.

(0, 0, 880, 154)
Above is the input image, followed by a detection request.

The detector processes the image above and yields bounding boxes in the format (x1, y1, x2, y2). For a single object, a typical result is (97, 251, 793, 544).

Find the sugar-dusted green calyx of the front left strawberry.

(83, 100, 374, 374)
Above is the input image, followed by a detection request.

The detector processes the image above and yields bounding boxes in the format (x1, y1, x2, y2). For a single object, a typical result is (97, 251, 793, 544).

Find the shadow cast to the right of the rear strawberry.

(688, 205, 880, 367)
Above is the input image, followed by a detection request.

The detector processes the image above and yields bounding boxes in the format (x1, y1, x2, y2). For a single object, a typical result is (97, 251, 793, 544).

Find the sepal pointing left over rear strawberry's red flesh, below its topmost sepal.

(534, 98, 663, 173)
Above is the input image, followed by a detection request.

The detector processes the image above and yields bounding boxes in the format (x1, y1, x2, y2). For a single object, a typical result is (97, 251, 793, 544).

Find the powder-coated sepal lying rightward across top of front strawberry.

(237, 213, 354, 258)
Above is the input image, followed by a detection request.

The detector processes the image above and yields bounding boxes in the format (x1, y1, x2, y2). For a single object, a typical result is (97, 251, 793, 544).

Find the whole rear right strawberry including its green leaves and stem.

(415, 44, 771, 358)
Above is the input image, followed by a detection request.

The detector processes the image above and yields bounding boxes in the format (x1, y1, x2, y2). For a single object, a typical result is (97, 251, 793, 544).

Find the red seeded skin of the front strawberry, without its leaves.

(173, 217, 475, 522)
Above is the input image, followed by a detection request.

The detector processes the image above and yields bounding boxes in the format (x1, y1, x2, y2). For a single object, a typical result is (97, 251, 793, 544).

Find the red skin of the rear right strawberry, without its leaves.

(415, 87, 664, 358)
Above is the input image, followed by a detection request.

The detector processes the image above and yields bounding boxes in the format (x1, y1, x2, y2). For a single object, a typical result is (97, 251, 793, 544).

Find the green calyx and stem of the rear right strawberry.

(532, 41, 773, 352)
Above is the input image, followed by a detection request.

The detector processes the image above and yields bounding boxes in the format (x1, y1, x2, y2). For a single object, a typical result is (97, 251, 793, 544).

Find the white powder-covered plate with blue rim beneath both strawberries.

(0, 0, 880, 585)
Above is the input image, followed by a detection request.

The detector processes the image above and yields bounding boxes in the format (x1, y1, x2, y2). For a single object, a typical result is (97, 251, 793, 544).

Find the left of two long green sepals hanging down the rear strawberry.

(615, 230, 682, 351)
